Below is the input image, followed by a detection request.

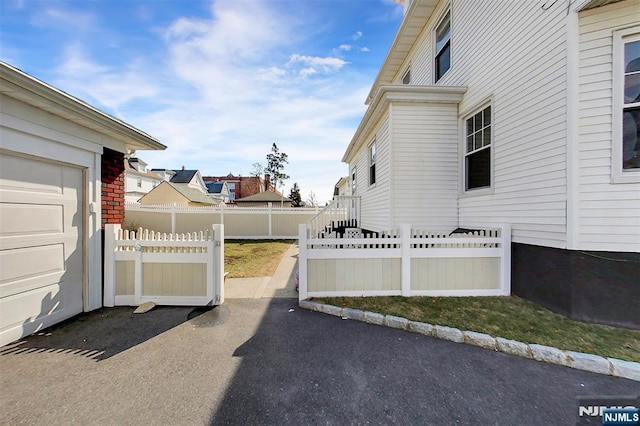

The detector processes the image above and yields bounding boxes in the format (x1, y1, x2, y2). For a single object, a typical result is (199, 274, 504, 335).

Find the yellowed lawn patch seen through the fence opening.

(224, 240, 295, 278)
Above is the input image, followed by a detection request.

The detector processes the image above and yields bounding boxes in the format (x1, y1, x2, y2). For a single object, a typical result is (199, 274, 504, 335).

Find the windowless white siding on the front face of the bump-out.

(392, 103, 458, 232)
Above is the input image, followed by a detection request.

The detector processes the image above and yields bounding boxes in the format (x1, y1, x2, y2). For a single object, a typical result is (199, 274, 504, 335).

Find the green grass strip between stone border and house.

(314, 296, 640, 362)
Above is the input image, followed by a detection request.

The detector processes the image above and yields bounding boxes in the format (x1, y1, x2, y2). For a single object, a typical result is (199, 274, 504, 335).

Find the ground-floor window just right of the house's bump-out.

(464, 106, 491, 190)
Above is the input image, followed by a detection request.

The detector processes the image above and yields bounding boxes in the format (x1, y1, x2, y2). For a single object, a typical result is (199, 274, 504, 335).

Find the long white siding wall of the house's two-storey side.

(394, 0, 567, 248)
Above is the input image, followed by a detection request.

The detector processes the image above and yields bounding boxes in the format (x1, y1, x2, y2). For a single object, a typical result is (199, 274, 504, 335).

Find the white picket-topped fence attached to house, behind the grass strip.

(299, 225, 511, 300)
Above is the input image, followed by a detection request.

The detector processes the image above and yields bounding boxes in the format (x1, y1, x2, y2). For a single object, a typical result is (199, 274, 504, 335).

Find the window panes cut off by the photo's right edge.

(622, 37, 640, 171)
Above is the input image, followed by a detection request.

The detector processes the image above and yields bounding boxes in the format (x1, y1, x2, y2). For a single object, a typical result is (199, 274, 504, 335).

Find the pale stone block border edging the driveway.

(299, 300, 640, 382)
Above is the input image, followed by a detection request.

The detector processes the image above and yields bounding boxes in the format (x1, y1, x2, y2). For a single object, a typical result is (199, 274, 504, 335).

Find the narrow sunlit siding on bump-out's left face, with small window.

(349, 112, 391, 231)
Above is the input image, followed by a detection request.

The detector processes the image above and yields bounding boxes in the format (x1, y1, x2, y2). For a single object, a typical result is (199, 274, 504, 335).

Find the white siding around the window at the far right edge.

(578, 0, 640, 252)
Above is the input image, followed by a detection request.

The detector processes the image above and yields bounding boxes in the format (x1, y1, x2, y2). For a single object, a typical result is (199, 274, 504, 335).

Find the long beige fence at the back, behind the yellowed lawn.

(125, 203, 319, 240)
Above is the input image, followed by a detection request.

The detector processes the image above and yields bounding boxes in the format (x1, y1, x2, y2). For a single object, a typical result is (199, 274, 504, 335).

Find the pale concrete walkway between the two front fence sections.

(224, 244, 298, 299)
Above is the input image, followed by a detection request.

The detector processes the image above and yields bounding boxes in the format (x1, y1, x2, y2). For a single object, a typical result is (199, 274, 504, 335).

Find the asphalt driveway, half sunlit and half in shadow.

(0, 298, 640, 425)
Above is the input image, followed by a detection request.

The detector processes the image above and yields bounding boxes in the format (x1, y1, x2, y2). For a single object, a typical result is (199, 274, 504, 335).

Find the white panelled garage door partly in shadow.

(0, 152, 84, 345)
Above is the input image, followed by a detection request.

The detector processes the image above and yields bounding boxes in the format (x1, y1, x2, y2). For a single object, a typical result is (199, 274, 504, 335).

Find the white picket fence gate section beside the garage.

(104, 224, 224, 307)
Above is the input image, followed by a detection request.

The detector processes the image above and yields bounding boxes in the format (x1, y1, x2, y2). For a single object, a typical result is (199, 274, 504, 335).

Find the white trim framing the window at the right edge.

(611, 26, 640, 184)
